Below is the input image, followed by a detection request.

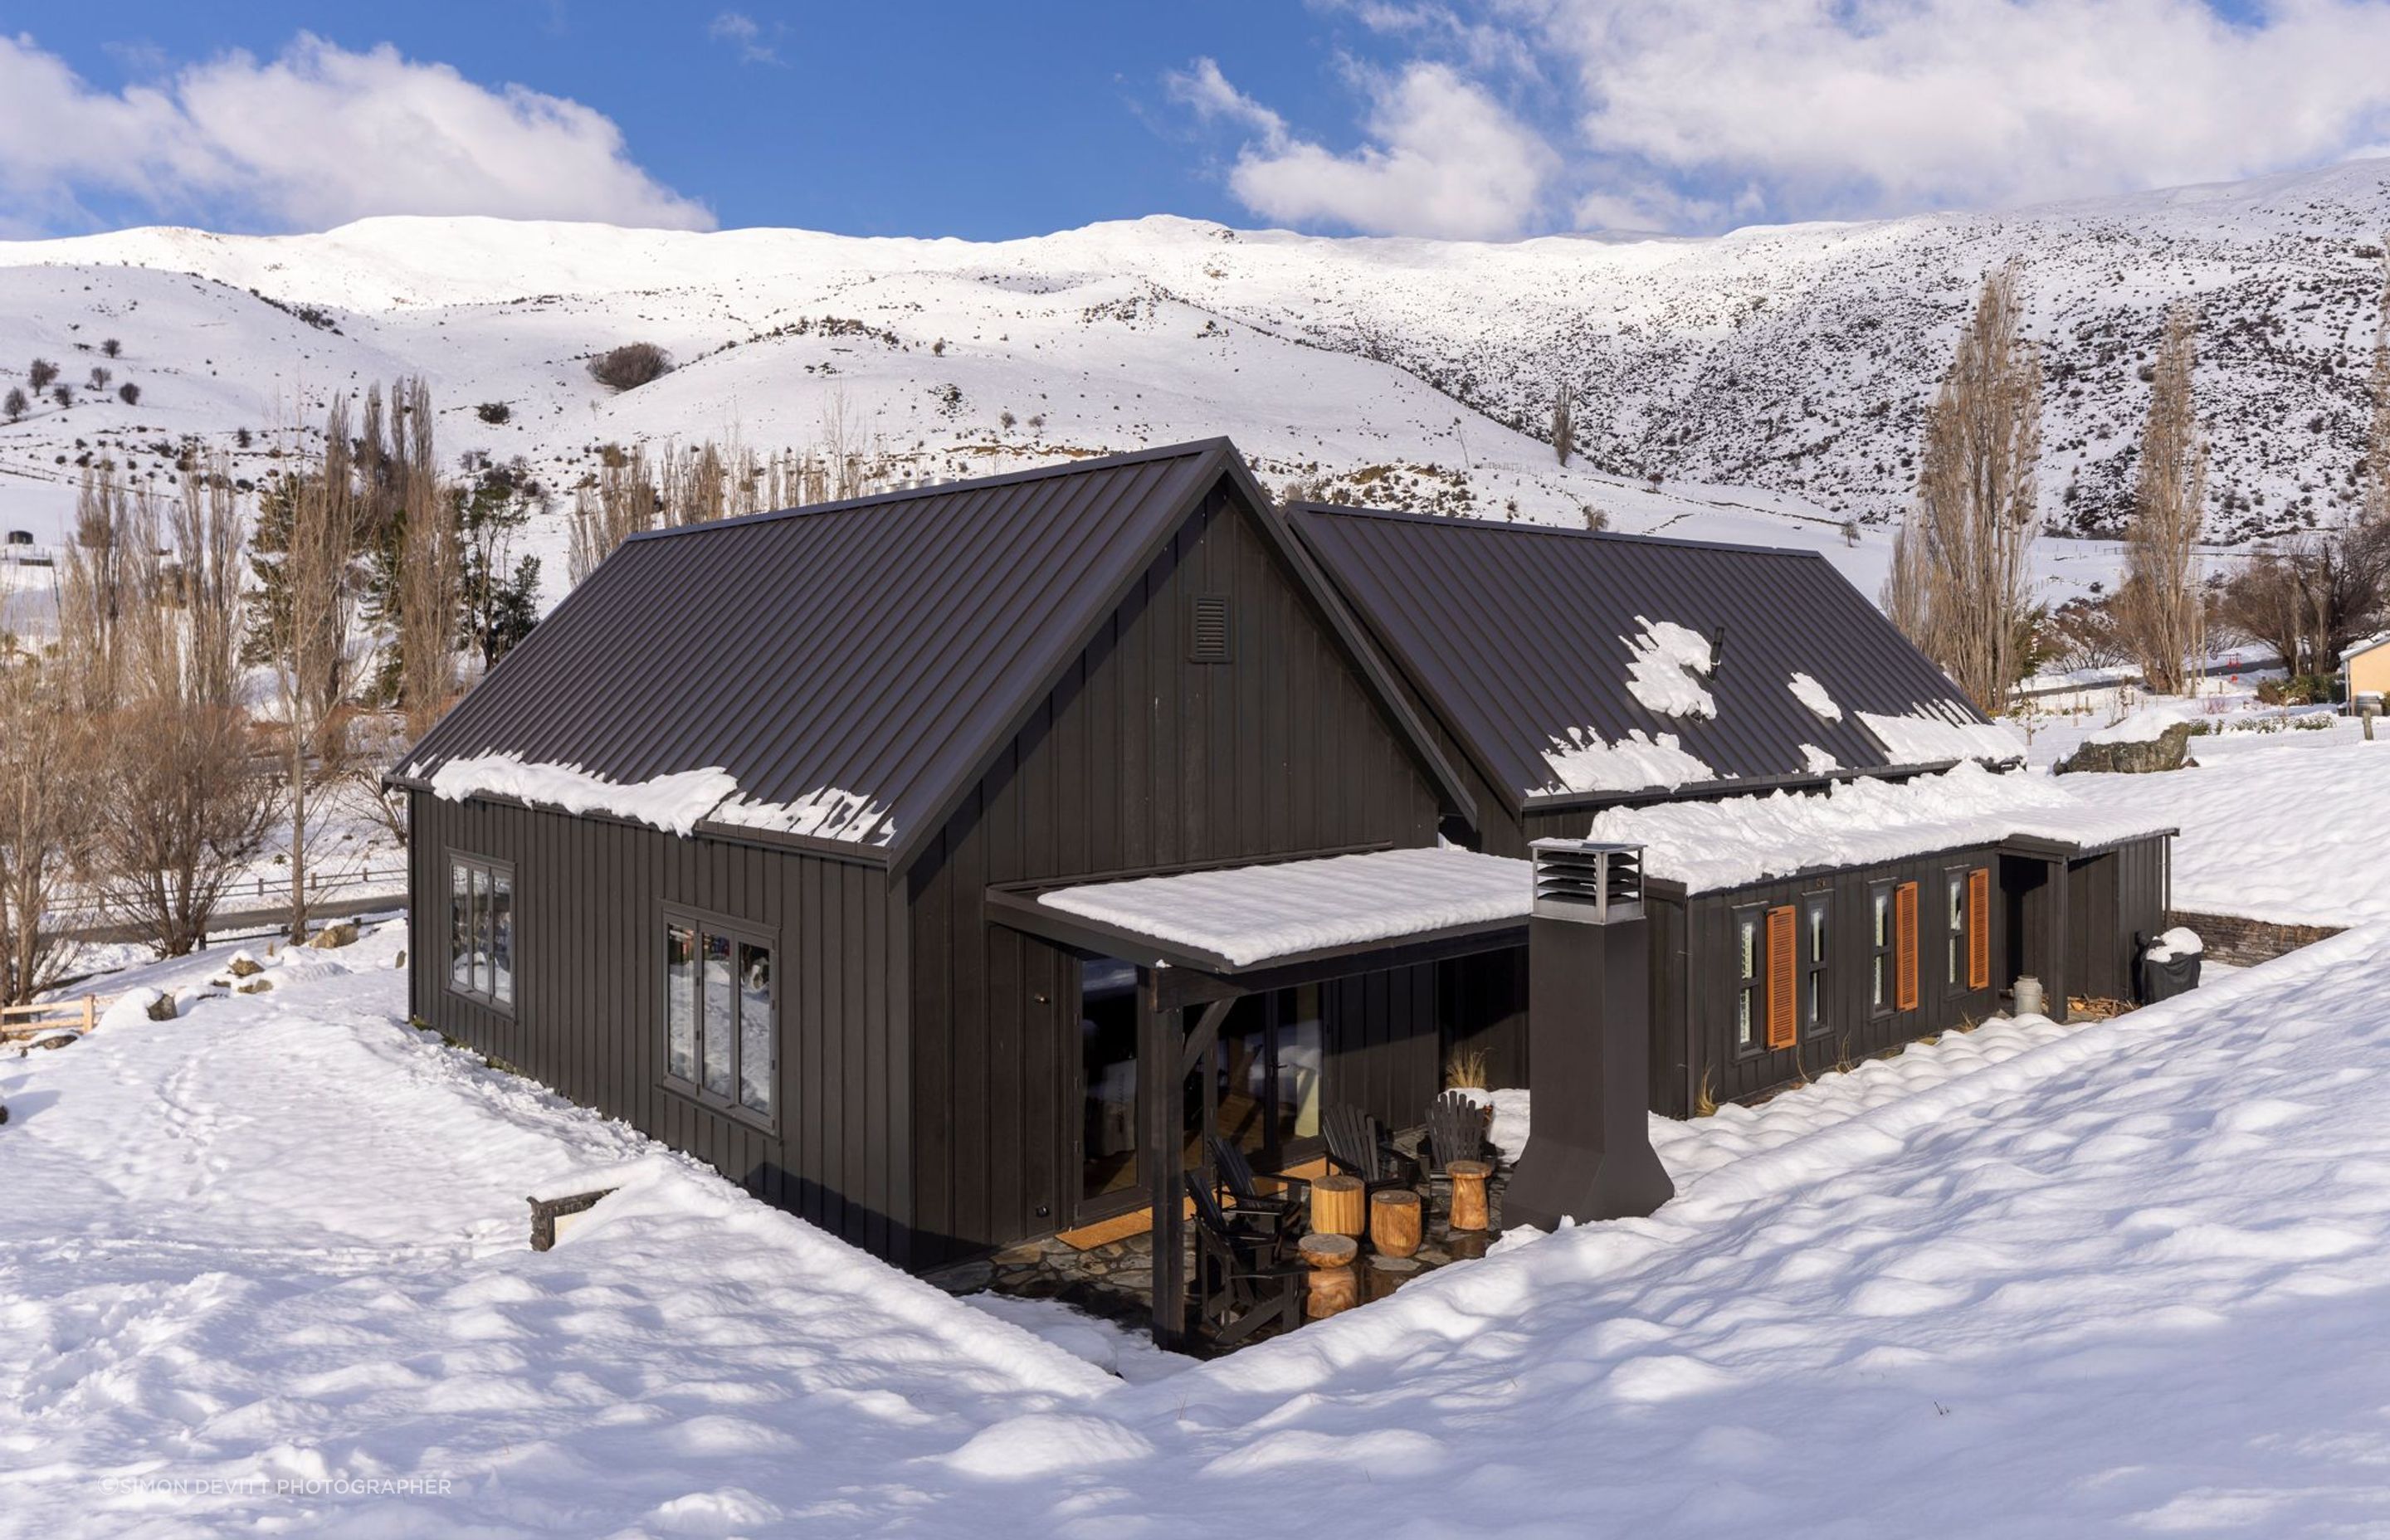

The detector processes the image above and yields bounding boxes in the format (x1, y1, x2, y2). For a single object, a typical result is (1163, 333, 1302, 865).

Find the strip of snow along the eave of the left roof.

(430, 753, 896, 844)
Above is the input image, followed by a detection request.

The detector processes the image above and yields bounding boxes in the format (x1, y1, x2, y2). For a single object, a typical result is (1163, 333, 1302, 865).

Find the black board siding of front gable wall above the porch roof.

(908, 483, 1441, 1260)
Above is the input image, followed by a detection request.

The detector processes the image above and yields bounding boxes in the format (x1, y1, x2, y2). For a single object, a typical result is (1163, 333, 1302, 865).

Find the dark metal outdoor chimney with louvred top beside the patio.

(1504, 840, 1675, 1229)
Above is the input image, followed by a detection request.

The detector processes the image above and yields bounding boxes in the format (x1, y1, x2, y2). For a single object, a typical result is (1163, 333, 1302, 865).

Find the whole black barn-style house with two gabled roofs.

(392, 440, 2165, 1329)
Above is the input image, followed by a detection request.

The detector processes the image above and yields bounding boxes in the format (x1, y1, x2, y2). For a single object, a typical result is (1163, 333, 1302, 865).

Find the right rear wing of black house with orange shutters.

(1288, 504, 2170, 1117)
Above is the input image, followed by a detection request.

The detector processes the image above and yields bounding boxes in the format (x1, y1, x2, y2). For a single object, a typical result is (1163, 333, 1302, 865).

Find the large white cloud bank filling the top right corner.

(1534, 0, 2390, 217)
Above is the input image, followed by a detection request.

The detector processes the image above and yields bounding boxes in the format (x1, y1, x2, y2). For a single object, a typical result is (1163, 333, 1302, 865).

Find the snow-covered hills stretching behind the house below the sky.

(0, 160, 2390, 597)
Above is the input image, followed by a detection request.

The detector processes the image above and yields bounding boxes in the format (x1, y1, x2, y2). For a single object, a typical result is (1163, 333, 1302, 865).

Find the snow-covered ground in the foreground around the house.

(0, 909, 2390, 1535)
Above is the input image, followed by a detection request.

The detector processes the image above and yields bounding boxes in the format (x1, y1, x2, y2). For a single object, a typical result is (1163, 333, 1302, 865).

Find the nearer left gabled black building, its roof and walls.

(392, 440, 1475, 1265)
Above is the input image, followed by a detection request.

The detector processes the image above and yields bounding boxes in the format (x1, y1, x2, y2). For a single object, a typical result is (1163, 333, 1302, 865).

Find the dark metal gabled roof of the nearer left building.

(392, 440, 1470, 865)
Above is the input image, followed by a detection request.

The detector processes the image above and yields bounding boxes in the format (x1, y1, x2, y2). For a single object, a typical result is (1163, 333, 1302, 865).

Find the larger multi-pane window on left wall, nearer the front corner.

(665, 914, 779, 1122)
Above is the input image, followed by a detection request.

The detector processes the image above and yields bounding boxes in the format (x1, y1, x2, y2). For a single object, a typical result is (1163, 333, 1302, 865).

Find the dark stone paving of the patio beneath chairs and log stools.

(927, 1136, 1510, 1329)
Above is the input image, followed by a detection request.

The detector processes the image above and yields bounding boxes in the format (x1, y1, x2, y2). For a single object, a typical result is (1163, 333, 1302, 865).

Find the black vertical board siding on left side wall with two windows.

(408, 792, 910, 1260)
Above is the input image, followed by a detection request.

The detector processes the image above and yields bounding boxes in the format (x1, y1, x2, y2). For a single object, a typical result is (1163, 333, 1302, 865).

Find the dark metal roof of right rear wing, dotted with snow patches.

(1288, 504, 1983, 811)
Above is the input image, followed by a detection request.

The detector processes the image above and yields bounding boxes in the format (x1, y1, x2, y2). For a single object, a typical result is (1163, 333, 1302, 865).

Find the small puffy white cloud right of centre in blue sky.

(1171, 60, 1556, 239)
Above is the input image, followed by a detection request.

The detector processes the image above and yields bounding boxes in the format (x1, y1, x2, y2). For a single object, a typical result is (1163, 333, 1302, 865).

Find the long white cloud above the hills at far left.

(0, 33, 715, 230)
